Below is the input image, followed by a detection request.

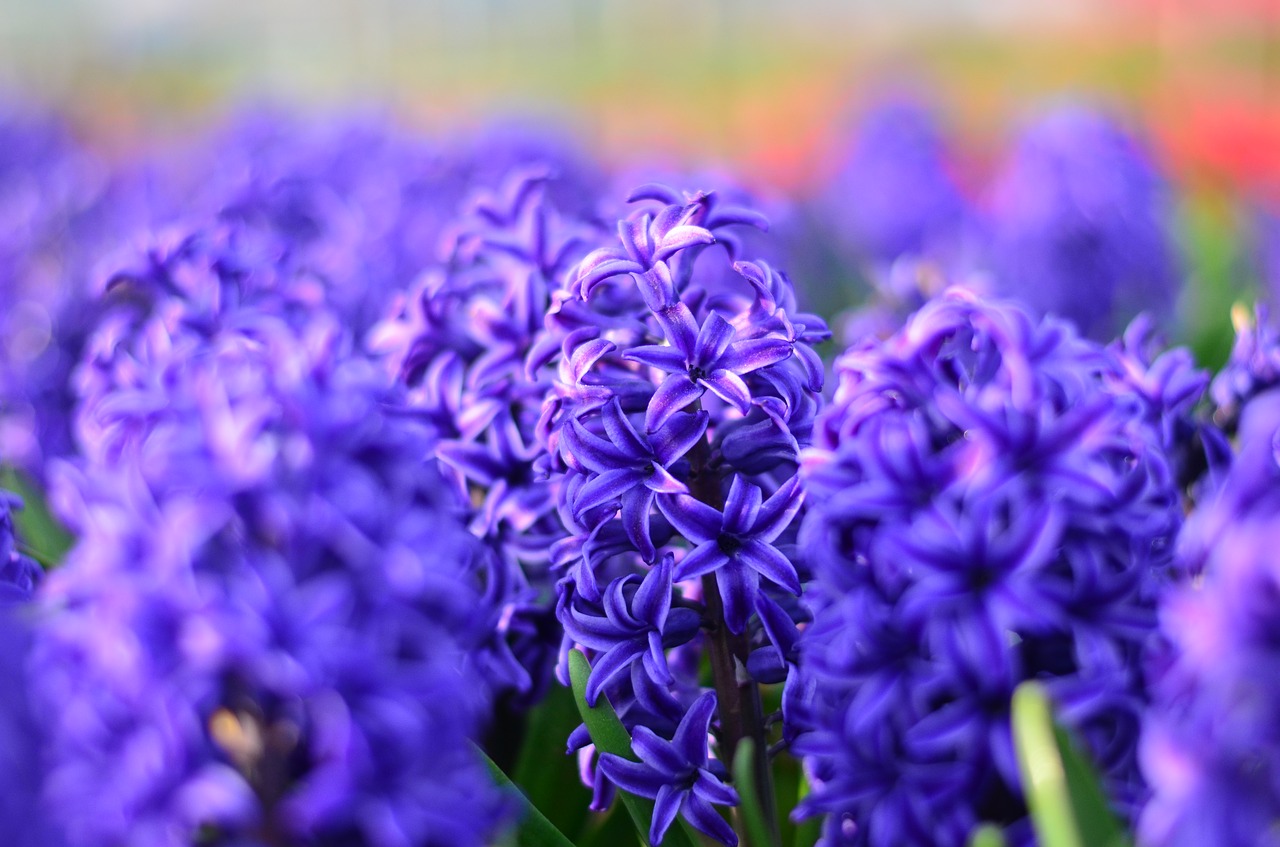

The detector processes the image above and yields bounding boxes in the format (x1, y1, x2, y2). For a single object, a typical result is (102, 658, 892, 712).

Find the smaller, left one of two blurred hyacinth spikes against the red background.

(822, 96, 973, 266)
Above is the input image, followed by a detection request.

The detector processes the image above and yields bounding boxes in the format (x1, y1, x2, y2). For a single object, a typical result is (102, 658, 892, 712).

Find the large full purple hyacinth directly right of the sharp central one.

(788, 289, 1181, 846)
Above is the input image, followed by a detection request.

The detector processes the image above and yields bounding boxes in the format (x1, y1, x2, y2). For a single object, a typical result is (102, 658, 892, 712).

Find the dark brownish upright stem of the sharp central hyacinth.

(689, 422, 781, 847)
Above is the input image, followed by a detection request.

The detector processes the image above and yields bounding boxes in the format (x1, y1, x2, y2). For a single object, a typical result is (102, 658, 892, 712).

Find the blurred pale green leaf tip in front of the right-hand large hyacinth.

(1012, 682, 1130, 847)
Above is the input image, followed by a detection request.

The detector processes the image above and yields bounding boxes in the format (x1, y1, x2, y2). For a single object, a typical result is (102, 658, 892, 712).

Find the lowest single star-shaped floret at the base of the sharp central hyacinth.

(600, 691, 739, 847)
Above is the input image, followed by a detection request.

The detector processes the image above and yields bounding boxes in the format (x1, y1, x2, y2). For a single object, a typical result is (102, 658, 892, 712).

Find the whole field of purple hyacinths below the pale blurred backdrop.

(0, 3, 1280, 847)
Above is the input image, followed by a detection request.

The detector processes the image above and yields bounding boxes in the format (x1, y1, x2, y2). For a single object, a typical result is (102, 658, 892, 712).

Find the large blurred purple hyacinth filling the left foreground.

(32, 212, 513, 847)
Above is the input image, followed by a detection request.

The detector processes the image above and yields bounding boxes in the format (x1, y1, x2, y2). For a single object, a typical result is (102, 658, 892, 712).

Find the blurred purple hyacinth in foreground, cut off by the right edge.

(1139, 390, 1280, 847)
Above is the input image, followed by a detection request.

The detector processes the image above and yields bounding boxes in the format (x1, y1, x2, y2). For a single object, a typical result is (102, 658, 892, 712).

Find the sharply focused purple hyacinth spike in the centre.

(529, 186, 828, 844)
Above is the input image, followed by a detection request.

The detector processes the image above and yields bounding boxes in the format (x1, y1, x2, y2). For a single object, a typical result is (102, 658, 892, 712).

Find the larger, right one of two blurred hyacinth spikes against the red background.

(989, 107, 1181, 340)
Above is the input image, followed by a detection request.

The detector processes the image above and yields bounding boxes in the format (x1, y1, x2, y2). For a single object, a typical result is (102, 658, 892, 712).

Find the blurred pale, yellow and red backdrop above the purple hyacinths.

(0, 0, 1280, 365)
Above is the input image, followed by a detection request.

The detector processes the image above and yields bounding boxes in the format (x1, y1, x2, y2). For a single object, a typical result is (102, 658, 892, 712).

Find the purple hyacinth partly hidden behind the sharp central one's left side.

(369, 164, 606, 704)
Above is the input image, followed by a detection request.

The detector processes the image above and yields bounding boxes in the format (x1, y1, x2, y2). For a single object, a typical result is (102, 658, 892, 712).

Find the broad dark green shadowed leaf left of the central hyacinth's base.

(511, 686, 591, 841)
